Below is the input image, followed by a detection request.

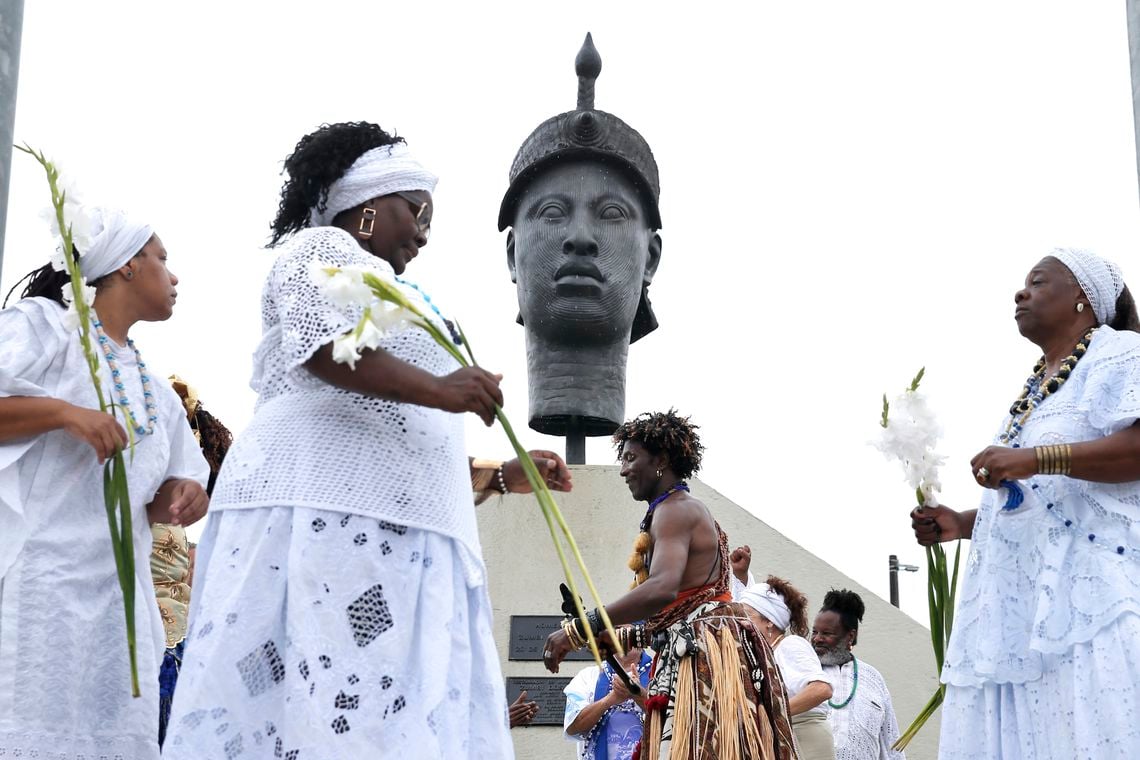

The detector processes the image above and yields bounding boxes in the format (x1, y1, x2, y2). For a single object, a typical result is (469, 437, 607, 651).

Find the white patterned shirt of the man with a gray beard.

(822, 660, 906, 760)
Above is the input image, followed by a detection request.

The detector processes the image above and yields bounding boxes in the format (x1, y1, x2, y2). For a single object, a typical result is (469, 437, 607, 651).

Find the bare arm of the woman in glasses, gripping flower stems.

(304, 343, 503, 426)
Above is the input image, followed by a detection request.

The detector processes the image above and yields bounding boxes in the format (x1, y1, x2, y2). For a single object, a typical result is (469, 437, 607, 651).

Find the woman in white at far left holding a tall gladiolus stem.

(0, 210, 209, 760)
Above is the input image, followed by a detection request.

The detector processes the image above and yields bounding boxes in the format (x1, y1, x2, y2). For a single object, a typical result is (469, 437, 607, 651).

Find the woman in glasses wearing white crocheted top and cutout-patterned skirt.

(164, 123, 569, 760)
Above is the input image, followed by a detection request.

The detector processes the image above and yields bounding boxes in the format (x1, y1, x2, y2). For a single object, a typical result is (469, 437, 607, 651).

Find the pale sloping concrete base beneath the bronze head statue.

(478, 465, 938, 760)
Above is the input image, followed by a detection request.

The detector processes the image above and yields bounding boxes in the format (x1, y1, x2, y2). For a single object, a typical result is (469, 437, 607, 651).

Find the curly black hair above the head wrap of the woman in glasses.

(267, 122, 404, 248)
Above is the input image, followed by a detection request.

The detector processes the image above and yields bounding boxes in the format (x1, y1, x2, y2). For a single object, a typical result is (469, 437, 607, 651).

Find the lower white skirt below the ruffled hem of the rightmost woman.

(938, 613, 1140, 760)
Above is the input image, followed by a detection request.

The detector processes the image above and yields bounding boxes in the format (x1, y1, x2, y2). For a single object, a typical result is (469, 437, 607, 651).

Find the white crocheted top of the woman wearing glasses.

(211, 227, 483, 586)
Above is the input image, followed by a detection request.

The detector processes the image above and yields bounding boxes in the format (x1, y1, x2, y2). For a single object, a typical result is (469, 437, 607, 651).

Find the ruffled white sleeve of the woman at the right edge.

(1077, 327, 1140, 435)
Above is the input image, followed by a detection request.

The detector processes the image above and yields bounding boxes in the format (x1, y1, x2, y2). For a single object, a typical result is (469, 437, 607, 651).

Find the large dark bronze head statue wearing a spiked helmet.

(498, 34, 661, 436)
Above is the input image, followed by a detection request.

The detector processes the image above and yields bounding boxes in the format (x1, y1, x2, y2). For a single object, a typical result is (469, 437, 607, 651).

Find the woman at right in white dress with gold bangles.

(913, 250, 1140, 760)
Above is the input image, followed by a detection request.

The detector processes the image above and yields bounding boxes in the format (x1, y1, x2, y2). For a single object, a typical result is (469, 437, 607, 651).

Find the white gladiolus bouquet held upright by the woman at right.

(874, 367, 962, 750)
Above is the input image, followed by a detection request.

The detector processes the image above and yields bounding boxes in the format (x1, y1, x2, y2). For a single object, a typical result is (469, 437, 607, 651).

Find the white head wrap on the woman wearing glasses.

(309, 142, 439, 227)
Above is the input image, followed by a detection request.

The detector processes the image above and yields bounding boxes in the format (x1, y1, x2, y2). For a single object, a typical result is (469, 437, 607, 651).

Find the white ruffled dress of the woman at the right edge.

(939, 327, 1140, 760)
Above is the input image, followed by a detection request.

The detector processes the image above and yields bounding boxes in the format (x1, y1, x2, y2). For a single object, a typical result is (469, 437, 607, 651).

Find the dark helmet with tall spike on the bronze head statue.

(498, 33, 661, 342)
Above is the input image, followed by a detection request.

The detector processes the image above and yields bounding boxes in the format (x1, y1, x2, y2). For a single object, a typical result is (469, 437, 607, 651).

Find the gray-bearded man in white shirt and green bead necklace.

(812, 589, 906, 760)
